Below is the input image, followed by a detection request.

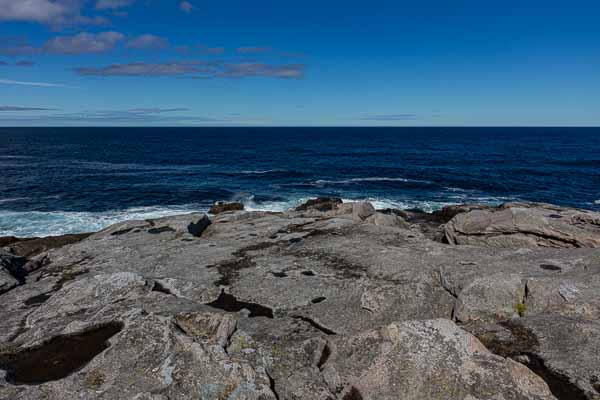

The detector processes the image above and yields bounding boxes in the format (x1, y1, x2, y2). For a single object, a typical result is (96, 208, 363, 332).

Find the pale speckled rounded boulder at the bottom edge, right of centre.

(323, 319, 554, 400)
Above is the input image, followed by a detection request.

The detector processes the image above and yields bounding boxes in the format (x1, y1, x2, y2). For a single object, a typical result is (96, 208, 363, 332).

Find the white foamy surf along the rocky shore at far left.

(0, 205, 206, 237)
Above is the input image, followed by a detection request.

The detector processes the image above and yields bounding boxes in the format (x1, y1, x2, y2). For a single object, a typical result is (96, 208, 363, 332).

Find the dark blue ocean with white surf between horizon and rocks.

(0, 128, 600, 237)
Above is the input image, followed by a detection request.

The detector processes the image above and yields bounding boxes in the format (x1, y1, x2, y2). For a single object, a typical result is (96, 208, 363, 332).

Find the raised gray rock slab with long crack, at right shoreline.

(445, 203, 600, 248)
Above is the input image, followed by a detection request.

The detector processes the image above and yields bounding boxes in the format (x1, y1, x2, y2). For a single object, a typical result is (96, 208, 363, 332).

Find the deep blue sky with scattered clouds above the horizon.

(0, 0, 600, 126)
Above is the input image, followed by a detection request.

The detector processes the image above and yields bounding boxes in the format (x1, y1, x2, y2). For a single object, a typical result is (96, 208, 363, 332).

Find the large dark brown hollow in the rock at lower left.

(0, 322, 123, 385)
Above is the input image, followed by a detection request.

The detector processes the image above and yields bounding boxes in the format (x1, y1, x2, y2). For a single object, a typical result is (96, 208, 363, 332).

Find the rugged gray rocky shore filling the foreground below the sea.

(0, 199, 600, 400)
